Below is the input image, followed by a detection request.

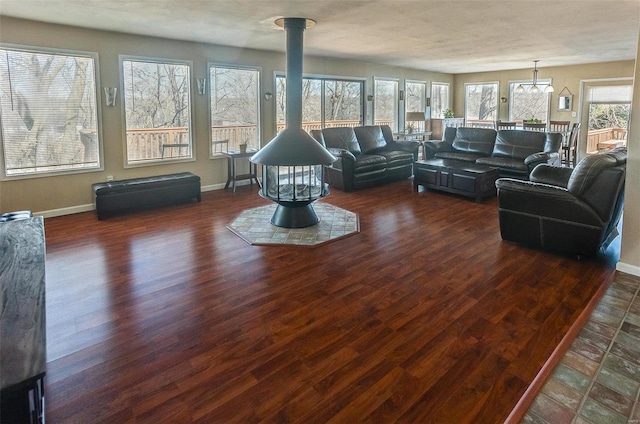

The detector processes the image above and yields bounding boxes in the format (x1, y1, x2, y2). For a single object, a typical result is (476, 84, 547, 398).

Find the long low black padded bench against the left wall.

(91, 172, 200, 219)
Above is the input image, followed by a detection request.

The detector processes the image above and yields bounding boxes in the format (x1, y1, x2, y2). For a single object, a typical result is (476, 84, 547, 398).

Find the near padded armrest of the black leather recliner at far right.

(496, 178, 602, 227)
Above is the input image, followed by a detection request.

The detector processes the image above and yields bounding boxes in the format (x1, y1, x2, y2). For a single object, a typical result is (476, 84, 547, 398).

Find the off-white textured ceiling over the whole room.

(0, 0, 640, 73)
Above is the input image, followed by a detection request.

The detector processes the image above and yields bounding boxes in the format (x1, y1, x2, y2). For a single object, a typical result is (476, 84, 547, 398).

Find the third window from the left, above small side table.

(209, 64, 260, 155)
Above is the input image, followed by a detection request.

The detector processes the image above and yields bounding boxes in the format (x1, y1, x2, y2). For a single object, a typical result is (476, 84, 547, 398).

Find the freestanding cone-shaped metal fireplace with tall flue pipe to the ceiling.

(251, 18, 336, 228)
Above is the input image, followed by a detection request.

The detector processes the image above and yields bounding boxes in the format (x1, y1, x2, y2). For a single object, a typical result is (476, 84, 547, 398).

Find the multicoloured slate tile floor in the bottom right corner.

(521, 272, 640, 424)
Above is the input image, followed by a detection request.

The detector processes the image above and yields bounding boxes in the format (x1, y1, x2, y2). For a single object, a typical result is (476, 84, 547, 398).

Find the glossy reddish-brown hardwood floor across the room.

(45, 181, 618, 424)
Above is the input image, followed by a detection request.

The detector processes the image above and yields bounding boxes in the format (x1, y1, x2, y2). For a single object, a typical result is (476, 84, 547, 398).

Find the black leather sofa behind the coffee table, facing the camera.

(424, 127, 562, 179)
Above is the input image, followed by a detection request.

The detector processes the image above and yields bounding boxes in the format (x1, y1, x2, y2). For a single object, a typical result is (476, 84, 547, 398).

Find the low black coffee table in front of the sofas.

(413, 159, 498, 202)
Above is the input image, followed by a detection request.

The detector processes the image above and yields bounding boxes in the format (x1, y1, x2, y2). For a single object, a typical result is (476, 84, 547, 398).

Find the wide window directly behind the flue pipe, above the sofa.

(276, 75, 364, 132)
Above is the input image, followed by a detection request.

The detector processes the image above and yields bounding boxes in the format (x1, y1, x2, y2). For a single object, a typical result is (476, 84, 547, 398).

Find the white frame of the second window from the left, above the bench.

(119, 55, 196, 168)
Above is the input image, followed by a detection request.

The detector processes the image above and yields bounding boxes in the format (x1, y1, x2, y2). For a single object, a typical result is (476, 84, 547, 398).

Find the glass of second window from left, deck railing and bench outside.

(121, 57, 193, 165)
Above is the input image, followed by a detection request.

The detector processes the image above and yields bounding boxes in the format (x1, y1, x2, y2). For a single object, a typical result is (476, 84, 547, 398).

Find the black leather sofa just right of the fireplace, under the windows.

(310, 125, 420, 191)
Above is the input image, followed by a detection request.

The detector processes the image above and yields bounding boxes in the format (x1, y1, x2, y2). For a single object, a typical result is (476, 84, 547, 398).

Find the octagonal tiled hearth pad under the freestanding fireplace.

(227, 202, 360, 247)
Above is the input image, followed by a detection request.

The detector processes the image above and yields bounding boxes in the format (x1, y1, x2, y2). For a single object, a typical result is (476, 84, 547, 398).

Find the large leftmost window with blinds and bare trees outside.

(0, 47, 101, 177)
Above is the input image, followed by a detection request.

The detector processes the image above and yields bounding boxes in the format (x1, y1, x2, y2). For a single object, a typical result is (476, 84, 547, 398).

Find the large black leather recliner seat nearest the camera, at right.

(496, 148, 627, 256)
